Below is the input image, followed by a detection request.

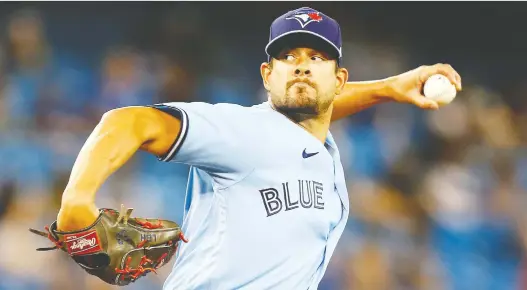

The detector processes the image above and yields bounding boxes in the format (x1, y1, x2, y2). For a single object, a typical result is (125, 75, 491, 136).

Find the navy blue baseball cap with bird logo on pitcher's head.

(265, 7, 342, 64)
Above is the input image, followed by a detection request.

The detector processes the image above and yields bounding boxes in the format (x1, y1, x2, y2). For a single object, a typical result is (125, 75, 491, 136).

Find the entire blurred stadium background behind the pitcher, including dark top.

(0, 2, 527, 290)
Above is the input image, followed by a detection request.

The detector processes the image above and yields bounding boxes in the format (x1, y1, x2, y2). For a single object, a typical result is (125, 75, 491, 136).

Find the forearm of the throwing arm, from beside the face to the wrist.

(331, 79, 389, 121)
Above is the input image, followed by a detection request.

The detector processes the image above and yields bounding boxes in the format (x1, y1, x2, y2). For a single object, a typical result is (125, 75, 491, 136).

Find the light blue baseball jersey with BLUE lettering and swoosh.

(152, 103, 349, 290)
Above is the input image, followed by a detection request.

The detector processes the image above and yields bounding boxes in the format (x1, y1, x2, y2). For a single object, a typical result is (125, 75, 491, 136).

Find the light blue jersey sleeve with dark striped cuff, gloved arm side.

(146, 102, 251, 179)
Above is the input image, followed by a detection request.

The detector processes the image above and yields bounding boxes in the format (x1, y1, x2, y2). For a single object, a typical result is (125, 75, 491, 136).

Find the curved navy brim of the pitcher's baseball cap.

(265, 30, 342, 60)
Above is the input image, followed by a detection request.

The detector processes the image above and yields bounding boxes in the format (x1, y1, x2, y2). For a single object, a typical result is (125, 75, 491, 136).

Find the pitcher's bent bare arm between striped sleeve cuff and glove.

(57, 107, 181, 231)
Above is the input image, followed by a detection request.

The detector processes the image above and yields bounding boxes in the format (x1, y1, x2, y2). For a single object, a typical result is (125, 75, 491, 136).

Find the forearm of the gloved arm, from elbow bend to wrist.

(62, 109, 144, 206)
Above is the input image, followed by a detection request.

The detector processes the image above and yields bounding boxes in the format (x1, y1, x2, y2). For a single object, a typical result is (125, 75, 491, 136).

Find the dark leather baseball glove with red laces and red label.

(29, 206, 187, 286)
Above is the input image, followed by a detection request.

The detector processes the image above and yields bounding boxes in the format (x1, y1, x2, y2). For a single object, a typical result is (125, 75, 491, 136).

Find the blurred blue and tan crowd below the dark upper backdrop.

(0, 5, 527, 290)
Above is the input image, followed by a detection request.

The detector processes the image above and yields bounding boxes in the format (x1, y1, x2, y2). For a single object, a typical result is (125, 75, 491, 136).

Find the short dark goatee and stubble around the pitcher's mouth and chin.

(272, 80, 333, 122)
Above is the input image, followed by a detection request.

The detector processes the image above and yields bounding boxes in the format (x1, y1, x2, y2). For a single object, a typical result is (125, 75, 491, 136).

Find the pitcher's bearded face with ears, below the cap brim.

(260, 47, 348, 118)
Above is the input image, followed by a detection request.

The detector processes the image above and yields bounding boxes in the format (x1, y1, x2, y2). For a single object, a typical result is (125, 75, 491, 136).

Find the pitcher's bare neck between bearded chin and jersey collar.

(271, 103, 333, 143)
